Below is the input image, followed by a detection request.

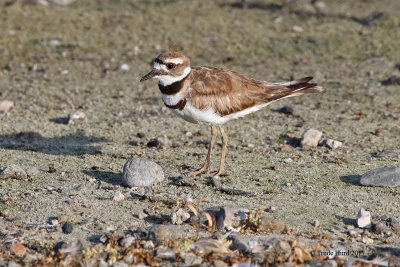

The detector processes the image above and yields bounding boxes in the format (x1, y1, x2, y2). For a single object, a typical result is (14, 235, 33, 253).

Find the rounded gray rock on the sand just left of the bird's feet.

(122, 158, 164, 187)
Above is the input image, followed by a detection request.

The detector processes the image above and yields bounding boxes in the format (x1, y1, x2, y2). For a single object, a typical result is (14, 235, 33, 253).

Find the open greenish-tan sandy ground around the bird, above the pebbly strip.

(0, 0, 400, 264)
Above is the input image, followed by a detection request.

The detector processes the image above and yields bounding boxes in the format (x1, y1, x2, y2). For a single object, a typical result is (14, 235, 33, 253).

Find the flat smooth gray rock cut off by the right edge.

(360, 167, 400, 187)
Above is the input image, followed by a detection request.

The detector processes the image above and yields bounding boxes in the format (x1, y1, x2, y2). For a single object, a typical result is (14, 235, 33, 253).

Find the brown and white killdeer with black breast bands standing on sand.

(140, 52, 323, 176)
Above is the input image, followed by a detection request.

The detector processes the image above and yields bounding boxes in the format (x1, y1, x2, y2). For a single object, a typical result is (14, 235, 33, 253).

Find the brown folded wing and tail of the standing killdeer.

(189, 67, 322, 116)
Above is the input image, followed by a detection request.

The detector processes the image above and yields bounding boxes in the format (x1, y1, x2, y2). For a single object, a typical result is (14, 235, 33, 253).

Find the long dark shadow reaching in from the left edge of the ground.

(0, 131, 108, 156)
